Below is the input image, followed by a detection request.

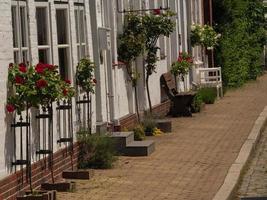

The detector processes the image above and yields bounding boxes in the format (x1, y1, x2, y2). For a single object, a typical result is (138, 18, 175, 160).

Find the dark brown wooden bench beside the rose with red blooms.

(160, 72, 196, 117)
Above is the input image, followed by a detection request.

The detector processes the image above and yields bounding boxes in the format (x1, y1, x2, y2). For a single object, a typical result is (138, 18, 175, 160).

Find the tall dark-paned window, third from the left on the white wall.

(56, 7, 70, 79)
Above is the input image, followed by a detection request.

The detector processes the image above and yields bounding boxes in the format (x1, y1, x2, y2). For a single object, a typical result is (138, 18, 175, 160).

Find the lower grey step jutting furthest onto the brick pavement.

(124, 140, 155, 156)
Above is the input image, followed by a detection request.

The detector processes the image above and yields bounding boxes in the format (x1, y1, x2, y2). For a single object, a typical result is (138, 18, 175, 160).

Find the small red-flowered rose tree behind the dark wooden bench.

(171, 52, 193, 91)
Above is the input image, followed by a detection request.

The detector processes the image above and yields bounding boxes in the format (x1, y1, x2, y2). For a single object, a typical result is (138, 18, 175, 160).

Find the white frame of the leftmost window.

(11, 1, 30, 63)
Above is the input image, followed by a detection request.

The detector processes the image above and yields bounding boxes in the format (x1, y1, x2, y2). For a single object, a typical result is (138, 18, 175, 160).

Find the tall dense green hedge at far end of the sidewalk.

(213, 0, 267, 87)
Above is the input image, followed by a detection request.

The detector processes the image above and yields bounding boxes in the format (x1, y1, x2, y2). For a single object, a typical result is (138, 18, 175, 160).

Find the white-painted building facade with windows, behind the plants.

(0, 0, 204, 197)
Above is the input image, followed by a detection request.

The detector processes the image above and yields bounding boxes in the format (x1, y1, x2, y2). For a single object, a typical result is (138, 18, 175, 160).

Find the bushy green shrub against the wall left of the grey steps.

(78, 132, 117, 169)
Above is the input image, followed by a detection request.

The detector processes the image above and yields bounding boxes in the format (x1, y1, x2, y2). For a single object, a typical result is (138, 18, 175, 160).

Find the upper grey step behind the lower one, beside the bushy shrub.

(110, 132, 134, 153)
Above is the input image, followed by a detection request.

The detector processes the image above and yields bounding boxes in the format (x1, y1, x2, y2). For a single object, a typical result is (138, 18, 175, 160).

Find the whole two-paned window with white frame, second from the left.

(36, 3, 52, 63)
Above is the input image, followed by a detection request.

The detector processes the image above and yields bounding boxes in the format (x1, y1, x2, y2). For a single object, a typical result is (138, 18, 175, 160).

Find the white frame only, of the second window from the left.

(35, 2, 53, 63)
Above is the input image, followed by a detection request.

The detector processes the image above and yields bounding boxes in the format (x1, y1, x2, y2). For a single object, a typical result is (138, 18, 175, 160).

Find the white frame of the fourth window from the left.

(74, 5, 88, 60)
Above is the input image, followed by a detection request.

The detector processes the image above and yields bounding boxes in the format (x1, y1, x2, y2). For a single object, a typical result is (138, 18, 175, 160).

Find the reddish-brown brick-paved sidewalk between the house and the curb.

(58, 75, 267, 200)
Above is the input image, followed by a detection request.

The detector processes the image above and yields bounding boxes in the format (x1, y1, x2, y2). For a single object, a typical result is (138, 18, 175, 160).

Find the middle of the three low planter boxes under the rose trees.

(41, 182, 75, 192)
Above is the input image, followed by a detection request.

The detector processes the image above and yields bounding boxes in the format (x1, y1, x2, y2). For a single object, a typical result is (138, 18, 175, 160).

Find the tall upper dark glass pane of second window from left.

(36, 8, 49, 45)
